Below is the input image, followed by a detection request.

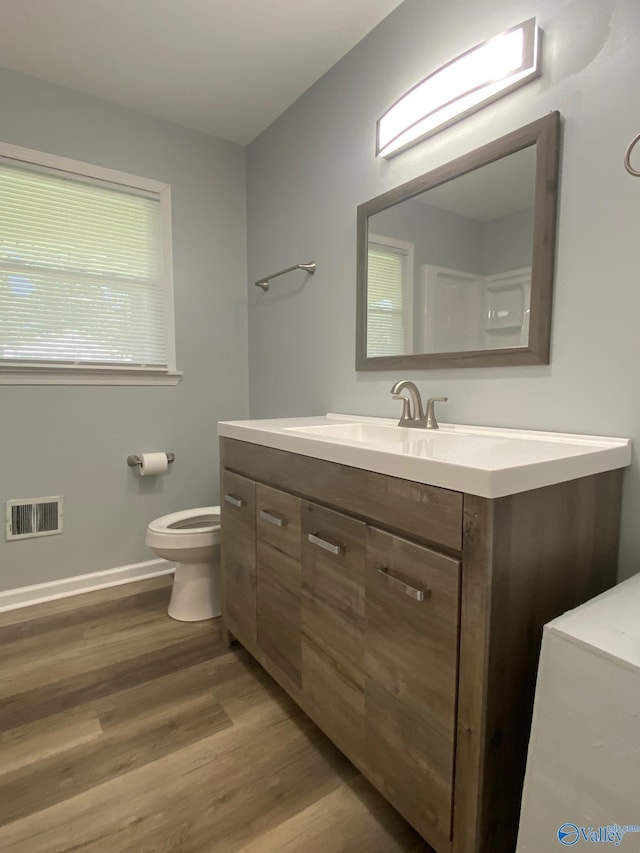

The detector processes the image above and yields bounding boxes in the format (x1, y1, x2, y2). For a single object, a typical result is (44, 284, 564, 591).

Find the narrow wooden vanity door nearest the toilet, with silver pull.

(220, 471, 256, 643)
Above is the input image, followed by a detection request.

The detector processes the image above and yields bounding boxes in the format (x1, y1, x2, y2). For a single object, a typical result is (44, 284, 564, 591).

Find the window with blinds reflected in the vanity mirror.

(367, 234, 413, 358)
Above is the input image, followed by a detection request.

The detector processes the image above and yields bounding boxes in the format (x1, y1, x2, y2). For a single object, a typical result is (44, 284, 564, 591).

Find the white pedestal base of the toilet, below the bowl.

(169, 562, 222, 622)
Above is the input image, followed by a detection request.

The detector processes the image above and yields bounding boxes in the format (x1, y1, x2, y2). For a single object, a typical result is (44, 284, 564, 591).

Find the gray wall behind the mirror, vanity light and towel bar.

(247, 0, 640, 576)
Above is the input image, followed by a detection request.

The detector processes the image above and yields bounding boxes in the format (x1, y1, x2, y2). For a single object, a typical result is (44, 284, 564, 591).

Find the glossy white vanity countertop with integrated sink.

(218, 414, 631, 498)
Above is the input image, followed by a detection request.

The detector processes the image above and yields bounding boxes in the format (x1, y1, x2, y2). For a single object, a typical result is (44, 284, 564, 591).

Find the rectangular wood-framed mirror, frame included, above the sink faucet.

(356, 112, 560, 370)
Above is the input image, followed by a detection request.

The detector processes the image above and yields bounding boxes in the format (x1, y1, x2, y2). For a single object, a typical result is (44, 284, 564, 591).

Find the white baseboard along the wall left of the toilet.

(0, 560, 175, 613)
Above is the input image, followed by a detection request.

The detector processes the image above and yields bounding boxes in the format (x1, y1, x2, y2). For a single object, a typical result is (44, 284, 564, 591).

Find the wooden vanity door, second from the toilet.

(256, 484, 301, 687)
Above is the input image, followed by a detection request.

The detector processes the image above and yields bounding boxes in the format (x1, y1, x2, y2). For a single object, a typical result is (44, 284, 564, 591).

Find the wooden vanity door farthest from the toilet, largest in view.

(364, 527, 460, 849)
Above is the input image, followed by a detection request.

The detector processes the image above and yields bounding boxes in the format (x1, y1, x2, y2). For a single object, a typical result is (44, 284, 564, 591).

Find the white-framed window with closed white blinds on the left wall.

(0, 145, 180, 384)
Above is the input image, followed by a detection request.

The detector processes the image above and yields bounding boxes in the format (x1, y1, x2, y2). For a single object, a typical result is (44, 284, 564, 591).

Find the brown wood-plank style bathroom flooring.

(0, 578, 430, 853)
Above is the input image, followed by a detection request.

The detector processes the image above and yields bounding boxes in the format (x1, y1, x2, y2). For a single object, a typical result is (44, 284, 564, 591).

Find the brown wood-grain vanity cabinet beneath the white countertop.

(221, 438, 622, 853)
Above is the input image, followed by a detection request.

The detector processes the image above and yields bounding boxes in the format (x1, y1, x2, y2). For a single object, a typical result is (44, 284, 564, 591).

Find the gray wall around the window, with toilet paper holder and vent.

(0, 71, 248, 589)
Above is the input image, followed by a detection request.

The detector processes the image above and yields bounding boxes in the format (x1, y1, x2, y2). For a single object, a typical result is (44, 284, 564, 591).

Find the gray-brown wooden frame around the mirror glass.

(356, 112, 560, 371)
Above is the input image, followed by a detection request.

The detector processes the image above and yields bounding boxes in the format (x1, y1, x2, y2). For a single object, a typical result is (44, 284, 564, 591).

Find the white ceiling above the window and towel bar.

(0, 0, 402, 145)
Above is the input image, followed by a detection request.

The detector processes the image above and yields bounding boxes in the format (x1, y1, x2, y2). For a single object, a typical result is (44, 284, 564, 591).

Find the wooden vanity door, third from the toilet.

(302, 503, 366, 761)
